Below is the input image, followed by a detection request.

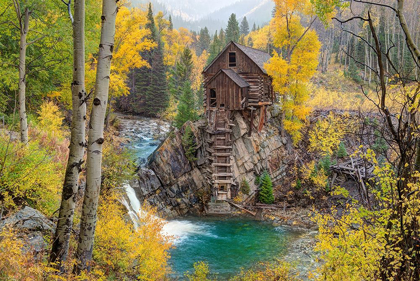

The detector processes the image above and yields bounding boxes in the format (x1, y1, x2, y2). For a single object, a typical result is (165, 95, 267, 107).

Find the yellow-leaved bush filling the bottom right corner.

(314, 150, 420, 280)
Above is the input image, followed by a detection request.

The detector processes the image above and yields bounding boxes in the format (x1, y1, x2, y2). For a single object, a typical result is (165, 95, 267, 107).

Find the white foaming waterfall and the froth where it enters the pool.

(121, 184, 210, 244)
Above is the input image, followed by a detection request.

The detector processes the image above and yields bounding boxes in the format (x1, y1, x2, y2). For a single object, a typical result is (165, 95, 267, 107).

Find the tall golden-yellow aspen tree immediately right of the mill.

(265, 0, 321, 144)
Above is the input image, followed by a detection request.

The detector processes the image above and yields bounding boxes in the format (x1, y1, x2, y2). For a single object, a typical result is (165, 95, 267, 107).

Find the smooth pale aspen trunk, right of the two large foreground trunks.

(74, 0, 118, 274)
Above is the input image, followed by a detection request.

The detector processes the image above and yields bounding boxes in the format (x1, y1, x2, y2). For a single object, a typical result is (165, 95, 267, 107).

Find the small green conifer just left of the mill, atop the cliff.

(175, 81, 198, 129)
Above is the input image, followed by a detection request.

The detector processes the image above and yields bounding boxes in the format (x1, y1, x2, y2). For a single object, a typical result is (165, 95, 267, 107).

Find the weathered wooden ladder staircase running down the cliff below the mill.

(207, 109, 234, 200)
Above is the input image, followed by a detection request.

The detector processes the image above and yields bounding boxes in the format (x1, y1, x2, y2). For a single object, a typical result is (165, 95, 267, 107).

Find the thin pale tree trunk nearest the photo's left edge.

(18, 8, 31, 144)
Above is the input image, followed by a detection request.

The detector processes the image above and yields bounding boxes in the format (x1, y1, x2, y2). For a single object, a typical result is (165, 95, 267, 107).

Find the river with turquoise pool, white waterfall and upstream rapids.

(121, 114, 316, 280)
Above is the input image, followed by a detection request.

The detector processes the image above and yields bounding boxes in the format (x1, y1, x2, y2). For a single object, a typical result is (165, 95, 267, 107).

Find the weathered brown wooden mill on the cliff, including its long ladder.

(203, 42, 274, 200)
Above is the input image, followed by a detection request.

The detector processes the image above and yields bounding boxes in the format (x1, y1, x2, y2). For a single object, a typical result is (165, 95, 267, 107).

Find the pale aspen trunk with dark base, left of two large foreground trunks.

(50, 0, 86, 271)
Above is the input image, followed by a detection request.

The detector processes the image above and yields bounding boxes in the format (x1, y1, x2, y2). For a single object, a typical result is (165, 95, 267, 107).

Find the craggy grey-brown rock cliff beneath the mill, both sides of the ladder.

(131, 108, 291, 217)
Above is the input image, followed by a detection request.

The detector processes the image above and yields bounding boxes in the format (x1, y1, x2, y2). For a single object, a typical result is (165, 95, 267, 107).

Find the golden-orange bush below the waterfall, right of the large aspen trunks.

(94, 195, 171, 280)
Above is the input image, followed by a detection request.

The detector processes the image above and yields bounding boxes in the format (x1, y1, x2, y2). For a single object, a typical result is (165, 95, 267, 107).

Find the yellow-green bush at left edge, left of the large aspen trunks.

(0, 134, 64, 215)
